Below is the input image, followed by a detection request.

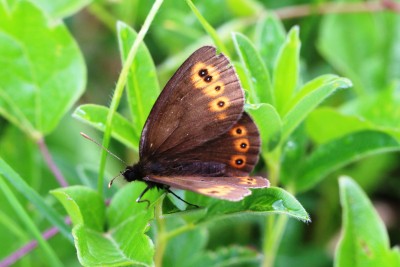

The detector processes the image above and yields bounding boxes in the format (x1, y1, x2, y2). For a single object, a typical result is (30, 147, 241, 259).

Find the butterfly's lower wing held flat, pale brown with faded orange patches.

(144, 175, 269, 201)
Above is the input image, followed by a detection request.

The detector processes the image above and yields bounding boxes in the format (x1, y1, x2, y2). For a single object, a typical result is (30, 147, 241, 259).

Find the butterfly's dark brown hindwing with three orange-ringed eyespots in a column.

(177, 112, 260, 176)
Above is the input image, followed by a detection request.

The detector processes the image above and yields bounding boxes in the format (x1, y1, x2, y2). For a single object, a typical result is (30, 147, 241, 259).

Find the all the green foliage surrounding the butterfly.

(0, 0, 400, 266)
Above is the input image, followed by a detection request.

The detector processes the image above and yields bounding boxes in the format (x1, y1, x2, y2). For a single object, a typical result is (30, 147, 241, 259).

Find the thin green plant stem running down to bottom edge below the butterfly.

(154, 198, 167, 267)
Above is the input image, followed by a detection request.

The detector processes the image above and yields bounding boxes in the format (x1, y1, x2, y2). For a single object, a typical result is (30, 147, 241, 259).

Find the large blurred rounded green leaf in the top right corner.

(318, 9, 400, 96)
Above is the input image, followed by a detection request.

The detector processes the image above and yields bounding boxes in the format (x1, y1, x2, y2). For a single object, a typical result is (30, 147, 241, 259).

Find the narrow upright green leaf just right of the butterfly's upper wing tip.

(232, 33, 274, 105)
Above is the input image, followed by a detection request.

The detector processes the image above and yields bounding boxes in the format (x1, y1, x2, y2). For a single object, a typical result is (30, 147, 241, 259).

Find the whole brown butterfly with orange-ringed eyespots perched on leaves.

(110, 46, 269, 204)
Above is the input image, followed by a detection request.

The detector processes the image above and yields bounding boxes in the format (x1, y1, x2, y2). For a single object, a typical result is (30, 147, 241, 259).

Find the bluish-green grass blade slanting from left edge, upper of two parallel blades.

(0, 158, 72, 241)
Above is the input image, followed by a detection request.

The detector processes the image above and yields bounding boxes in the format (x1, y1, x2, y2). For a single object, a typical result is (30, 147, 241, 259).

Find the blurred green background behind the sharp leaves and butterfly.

(0, 0, 400, 267)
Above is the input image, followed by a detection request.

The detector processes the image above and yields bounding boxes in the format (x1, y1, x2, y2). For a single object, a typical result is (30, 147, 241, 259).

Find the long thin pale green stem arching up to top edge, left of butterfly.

(97, 0, 163, 196)
